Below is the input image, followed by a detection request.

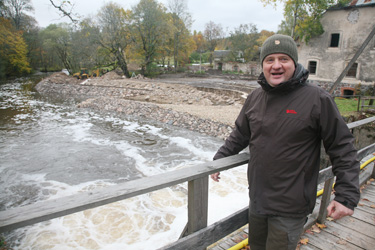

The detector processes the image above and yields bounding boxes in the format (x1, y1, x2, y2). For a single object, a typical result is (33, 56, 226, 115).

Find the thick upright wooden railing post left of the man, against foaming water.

(187, 176, 208, 234)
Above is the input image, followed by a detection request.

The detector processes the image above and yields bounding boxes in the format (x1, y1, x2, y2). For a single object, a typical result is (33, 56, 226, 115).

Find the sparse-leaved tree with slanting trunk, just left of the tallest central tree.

(98, 3, 133, 78)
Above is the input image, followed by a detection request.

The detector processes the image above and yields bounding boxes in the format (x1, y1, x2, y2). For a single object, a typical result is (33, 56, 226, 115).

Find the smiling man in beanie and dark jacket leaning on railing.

(211, 34, 360, 250)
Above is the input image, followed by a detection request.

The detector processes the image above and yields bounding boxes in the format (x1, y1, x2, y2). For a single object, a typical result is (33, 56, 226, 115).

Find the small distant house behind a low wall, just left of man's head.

(213, 50, 259, 75)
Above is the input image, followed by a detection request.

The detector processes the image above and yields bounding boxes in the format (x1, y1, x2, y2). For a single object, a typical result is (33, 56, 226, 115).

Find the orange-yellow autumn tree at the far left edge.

(0, 17, 31, 78)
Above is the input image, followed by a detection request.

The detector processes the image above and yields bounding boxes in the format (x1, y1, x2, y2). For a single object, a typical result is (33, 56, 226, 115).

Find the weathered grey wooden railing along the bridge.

(0, 117, 375, 250)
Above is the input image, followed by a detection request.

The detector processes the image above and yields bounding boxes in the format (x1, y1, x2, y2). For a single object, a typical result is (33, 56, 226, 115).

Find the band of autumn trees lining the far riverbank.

(0, 0, 352, 78)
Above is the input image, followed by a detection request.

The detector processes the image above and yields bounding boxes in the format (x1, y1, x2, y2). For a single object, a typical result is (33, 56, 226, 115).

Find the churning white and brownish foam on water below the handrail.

(9, 163, 248, 250)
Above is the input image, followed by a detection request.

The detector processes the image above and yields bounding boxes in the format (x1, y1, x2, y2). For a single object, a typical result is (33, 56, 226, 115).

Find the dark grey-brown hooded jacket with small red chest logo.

(214, 65, 360, 217)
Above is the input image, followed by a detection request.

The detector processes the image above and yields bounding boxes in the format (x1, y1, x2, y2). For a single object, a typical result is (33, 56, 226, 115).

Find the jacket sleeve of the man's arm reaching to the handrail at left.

(214, 97, 250, 160)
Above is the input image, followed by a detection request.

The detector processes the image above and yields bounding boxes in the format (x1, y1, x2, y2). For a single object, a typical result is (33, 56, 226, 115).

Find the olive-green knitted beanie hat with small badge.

(260, 34, 298, 65)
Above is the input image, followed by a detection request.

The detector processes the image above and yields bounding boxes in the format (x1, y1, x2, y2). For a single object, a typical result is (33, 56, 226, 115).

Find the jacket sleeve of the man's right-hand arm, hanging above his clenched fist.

(319, 93, 360, 210)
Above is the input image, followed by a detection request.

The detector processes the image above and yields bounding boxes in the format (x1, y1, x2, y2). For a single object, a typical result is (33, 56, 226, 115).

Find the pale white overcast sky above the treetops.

(31, 0, 283, 34)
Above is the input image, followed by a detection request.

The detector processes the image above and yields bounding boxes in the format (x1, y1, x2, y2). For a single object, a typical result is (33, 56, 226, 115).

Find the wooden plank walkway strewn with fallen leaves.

(207, 181, 375, 250)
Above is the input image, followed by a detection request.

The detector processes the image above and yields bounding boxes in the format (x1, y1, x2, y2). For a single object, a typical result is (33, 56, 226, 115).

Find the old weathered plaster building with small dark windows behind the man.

(298, 0, 375, 95)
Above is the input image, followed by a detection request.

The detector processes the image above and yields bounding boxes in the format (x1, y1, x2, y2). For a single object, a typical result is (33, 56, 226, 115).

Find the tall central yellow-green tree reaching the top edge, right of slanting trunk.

(132, 0, 171, 74)
